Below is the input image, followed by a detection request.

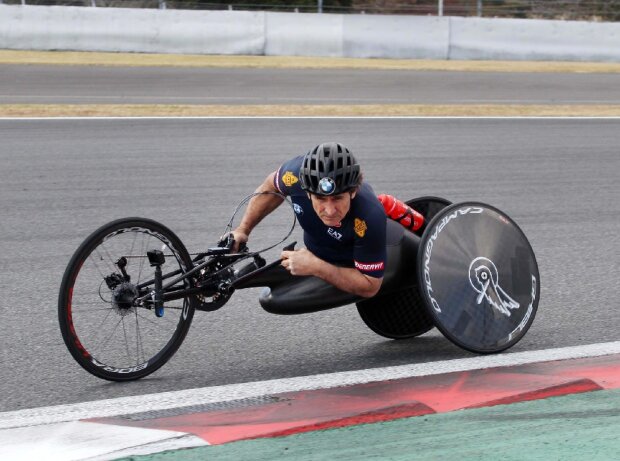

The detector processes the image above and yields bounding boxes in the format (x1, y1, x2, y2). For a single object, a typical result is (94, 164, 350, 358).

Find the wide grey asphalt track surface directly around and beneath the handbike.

(0, 119, 620, 411)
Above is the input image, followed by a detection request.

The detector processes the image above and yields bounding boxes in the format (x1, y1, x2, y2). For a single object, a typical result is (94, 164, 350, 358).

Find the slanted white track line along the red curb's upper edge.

(0, 341, 620, 429)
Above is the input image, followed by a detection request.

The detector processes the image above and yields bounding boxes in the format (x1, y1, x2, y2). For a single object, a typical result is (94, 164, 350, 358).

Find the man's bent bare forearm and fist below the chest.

(282, 249, 383, 298)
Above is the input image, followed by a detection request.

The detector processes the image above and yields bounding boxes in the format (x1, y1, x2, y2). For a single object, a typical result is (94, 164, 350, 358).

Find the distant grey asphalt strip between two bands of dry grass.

(0, 64, 620, 105)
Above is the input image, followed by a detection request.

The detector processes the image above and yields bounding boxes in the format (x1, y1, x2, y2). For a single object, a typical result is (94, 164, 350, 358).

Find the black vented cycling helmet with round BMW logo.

(299, 142, 361, 195)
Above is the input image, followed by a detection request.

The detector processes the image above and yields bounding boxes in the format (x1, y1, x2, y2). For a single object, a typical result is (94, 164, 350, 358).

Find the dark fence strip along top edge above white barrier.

(0, 0, 620, 21)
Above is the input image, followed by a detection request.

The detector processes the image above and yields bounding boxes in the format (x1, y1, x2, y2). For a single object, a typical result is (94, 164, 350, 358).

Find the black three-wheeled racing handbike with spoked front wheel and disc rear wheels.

(58, 197, 540, 381)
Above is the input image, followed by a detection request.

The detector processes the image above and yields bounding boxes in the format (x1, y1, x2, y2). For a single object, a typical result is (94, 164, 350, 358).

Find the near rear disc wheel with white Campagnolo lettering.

(417, 202, 540, 354)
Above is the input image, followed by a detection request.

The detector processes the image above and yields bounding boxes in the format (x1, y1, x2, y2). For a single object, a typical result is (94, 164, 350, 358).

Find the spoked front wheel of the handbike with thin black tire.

(58, 218, 195, 381)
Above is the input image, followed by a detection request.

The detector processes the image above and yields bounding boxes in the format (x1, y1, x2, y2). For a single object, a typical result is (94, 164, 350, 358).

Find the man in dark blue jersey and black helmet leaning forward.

(232, 142, 386, 297)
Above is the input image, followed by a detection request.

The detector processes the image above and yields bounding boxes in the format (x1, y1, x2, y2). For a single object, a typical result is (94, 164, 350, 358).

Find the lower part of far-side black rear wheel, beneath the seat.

(357, 286, 434, 339)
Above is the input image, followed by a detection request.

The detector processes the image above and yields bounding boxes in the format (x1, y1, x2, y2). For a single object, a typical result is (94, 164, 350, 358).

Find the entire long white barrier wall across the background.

(0, 4, 620, 61)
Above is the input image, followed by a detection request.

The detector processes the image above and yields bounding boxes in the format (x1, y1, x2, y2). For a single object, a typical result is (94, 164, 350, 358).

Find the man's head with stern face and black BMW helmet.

(300, 142, 362, 226)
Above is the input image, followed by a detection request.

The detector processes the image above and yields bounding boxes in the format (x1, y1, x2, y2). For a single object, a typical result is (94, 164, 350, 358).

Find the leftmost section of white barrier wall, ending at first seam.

(0, 5, 265, 54)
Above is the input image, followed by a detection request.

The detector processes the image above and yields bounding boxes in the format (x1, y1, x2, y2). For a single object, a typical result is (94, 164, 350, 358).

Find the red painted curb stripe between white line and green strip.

(94, 354, 620, 445)
